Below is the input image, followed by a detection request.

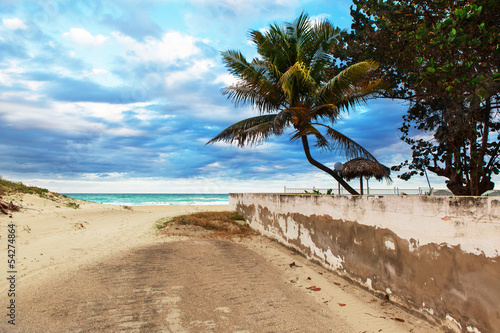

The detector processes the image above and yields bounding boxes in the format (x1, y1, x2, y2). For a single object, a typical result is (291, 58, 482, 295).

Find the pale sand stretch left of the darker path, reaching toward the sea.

(0, 195, 228, 294)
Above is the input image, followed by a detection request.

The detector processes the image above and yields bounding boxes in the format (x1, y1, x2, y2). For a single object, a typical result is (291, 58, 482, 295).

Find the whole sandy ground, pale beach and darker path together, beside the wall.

(0, 193, 439, 332)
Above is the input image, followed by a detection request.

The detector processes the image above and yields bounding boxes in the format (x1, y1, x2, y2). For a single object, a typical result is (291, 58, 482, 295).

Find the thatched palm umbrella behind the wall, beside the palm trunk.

(342, 157, 392, 194)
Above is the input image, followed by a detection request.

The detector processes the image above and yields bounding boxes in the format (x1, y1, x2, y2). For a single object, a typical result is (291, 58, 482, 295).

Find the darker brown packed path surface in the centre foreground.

(15, 240, 356, 333)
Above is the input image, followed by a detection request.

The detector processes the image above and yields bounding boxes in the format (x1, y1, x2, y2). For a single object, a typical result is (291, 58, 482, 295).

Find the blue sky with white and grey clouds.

(0, 0, 482, 193)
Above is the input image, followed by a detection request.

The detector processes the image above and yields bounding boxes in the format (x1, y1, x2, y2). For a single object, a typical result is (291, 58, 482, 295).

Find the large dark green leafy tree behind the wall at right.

(344, 0, 500, 195)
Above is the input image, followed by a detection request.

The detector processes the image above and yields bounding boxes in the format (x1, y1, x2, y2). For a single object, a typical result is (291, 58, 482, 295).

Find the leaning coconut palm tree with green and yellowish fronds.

(207, 13, 382, 194)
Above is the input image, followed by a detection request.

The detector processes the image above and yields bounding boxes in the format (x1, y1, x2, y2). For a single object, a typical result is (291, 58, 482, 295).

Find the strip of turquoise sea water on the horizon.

(64, 193, 229, 206)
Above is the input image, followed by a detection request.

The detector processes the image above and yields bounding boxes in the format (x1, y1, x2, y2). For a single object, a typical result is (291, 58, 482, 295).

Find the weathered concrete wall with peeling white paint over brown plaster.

(229, 193, 500, 333)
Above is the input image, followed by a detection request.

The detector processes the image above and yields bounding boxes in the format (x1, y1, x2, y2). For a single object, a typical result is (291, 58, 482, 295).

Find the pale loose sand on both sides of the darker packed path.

(0, 195, 440, 332)
